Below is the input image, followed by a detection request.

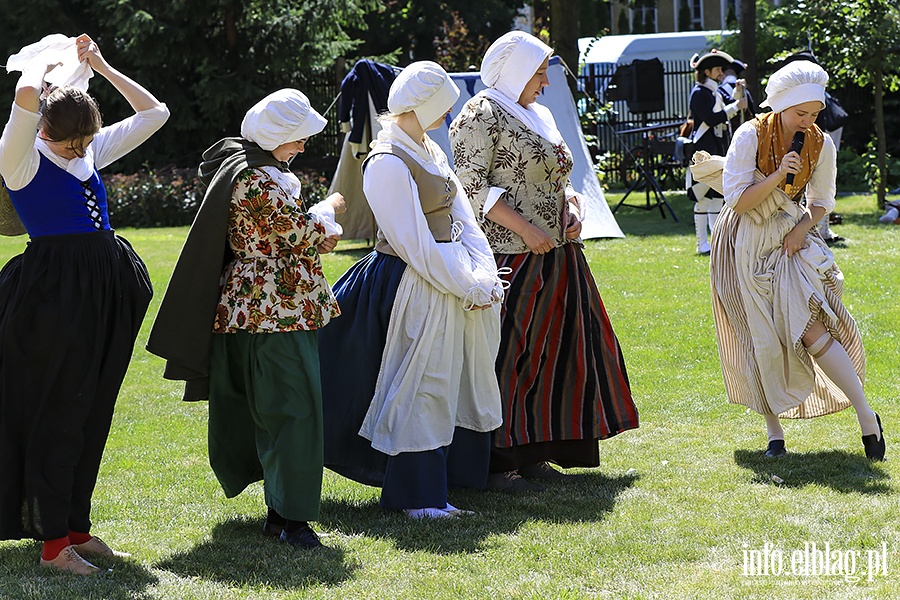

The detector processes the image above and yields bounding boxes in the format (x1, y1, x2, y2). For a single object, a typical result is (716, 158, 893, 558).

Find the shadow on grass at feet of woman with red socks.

(0, 542, 159, 600)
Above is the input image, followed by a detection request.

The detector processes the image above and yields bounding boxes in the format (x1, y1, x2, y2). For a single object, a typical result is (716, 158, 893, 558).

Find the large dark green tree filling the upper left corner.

(2, 0, 380, 168)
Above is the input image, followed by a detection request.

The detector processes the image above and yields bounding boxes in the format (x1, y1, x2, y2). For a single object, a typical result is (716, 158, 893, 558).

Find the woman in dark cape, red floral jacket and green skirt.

(147, 89, 344, 548)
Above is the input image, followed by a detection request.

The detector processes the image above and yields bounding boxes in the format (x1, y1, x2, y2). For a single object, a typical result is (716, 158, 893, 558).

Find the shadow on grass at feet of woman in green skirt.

(155, 518, 353, 589)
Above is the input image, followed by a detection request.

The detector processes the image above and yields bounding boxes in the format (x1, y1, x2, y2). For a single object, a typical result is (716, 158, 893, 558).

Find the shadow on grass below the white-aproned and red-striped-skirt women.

(319, 472, 638, 554)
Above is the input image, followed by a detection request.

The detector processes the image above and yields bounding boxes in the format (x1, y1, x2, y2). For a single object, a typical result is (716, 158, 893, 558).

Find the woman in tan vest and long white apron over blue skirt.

(320, 61, 503, 518)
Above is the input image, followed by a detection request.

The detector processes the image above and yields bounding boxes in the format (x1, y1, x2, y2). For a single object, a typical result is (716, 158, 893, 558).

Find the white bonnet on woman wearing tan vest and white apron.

(388, 60, 459, 129)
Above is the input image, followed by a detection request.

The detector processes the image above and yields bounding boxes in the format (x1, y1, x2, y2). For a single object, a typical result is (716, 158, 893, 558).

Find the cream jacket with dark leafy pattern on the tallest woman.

(450, 96, 575, 254)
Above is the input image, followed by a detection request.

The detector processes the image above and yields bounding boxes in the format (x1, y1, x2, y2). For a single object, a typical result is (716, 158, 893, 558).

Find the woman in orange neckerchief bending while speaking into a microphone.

(710, 61, 885, 460)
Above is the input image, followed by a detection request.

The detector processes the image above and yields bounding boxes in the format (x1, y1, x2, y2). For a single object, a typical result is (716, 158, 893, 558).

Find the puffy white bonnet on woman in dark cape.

(241, 88, 328, 152)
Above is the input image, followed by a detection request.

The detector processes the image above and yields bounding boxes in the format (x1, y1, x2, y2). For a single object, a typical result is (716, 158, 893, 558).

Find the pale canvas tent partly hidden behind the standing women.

(329, 56, 625, 239)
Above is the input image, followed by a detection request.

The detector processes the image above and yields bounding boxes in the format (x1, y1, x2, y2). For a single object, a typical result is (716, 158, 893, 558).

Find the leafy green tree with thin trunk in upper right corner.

(762, 0, 900, 208)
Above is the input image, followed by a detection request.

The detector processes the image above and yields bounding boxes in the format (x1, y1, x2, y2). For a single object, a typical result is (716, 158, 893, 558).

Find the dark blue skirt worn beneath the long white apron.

(319, 251, 490, 500)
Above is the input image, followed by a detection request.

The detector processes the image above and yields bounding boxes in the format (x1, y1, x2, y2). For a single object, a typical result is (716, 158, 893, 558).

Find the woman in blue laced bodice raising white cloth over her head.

(0, 34, 169, 575)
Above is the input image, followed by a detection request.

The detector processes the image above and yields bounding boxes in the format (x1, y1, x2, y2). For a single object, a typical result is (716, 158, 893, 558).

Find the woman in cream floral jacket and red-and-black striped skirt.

(450, 32, 638, 491)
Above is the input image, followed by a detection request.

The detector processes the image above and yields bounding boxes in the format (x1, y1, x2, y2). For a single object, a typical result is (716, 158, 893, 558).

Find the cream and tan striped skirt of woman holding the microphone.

(710, 202, 865, 419)
